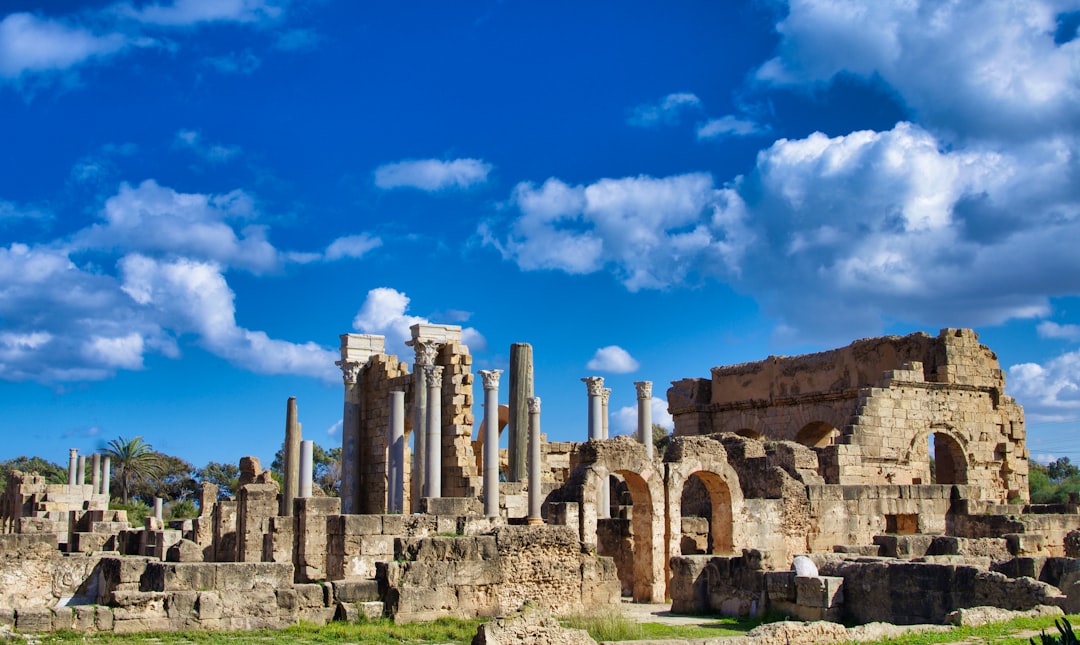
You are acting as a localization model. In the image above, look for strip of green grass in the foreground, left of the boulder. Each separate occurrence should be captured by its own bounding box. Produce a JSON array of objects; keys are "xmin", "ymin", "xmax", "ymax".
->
[{"xmin": 36, "ymin": 618, "xmax": 483, "ymax": 645}]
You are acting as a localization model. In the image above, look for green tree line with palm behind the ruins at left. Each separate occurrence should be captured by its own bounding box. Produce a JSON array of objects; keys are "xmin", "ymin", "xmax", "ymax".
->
[{"xmin": 0, "ymin": 436, "xmax": 341, "ymax": 523}]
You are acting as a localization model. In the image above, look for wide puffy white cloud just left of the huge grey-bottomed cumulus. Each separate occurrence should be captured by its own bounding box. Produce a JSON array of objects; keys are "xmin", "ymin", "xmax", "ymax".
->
[{"xmin": 481, "ymin": 173, "xmax": 752, "ymax": 291}]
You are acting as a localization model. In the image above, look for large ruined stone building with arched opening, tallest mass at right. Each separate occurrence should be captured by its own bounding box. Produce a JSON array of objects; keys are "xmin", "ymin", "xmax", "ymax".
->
[{"xmin": 667, "ymin": 330, "xmax": 1028, "ymax": 501}]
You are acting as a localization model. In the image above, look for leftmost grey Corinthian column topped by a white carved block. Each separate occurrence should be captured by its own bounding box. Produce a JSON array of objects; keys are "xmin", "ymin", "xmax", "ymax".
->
[{"xmin": 335, "ymin": 334, "xmax": 386, "ymax": 513}]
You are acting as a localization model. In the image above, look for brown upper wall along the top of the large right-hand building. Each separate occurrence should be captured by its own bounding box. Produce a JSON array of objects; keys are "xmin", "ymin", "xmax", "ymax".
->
[{"xmin": 708, "ymin": 328, "xmax": 1004, "ymax": 405}]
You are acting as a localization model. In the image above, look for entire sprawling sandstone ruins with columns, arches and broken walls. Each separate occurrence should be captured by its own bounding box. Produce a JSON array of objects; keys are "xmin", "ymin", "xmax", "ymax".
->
[{"xmin": 0, "ymin": 324, "xmax": 1080, "ymax": 637}]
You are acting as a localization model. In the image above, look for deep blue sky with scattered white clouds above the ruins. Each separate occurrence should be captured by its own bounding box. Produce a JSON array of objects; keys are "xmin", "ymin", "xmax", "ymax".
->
[{"xmin": 0, "ymin": 0, "xmax": 1080, "ymax": 473}]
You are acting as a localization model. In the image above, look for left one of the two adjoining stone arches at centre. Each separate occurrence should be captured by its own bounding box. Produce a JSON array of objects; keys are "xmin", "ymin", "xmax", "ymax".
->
[{"xmin": 571, "ymin": 436, "xmax": 667, "ymax": 603}]
